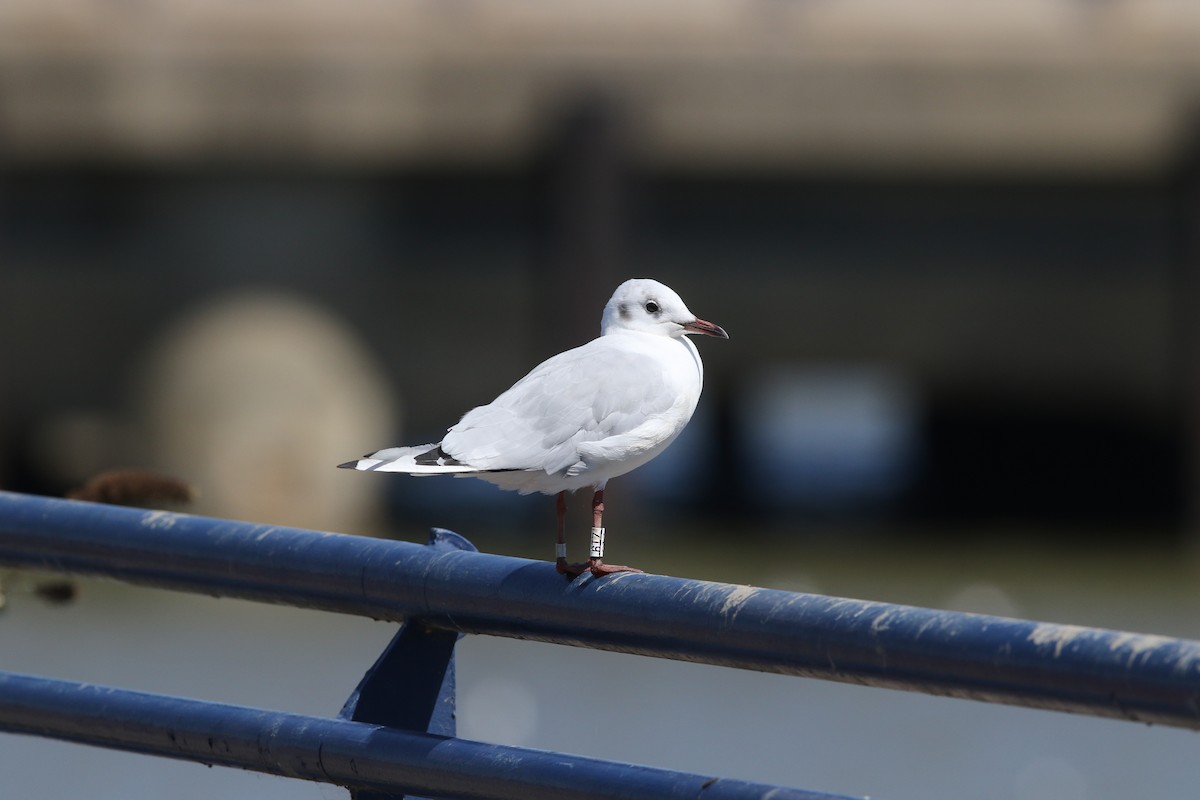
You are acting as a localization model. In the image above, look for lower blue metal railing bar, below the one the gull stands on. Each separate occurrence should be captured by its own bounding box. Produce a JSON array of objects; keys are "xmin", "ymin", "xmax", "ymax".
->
[{"xmin": 0, "ymin": 673, "xmax": 845, "ymax": 800}]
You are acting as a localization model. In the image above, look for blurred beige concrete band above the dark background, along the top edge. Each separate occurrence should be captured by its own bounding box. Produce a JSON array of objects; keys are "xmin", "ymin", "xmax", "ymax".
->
[{"xmin": 0, "ymin": 0, "xmax": 1200, "ymax": 170}]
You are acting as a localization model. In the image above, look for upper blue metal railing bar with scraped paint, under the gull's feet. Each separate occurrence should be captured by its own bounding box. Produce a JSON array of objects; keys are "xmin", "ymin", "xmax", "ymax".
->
[{"xmin": 0, "ymin": 492, "xmax": 1200, "ymax": 728}]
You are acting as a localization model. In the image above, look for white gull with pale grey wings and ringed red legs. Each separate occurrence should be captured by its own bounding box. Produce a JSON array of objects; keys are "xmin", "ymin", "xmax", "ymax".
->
[{"xmin": 338, "ymin": 278, "xmax": 728, "ymax": 576}]
